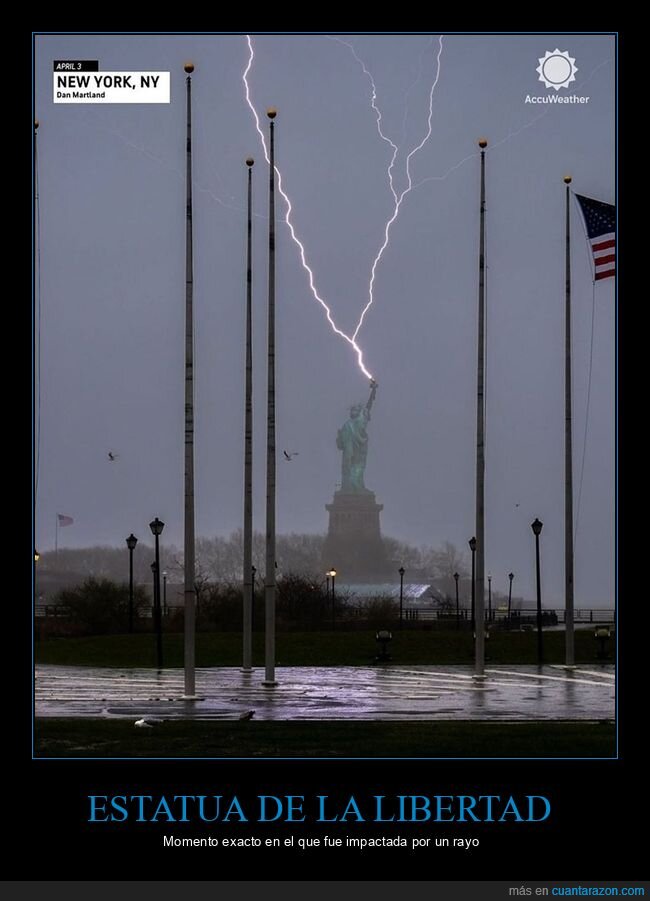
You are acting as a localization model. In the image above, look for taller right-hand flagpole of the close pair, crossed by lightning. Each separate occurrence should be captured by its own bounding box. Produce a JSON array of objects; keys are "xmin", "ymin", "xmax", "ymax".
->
[{"xmin": 263, "ymin": 109, "xmax": 277, "ymax": 687}]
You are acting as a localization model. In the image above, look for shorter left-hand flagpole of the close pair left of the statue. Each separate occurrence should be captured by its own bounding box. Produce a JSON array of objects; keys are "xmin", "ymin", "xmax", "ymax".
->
[{"xmin": 242, "ymin": 157, "xmax": 255, "ymax": 670}]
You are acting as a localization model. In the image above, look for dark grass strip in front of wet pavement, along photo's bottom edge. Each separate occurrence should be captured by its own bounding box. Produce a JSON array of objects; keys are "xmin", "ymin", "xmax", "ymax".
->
[{"xmin": 35, "ymin": 717, "xmax": 615, "ymax": 758}]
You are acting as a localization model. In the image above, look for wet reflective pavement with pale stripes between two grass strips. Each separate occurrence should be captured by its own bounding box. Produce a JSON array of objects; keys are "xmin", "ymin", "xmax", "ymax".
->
[{"xmin": 35, "ymin": 664, "xmax": 615, "ymax": 721}]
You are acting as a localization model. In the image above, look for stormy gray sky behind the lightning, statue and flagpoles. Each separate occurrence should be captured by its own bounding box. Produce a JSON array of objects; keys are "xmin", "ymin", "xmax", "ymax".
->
[{"xmin": 36, "ymin": 34, "xmax": 615, "ymax": 606}]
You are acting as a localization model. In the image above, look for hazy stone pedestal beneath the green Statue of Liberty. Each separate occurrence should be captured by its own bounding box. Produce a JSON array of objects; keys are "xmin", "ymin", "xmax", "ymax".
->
[{"xmin": 323, "ymin": 491, "xmax": 390, "ymax": 583}]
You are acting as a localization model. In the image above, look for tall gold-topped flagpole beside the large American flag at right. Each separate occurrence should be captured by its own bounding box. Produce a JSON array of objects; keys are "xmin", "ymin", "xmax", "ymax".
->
[{"xmin": 564, "ymin": 175, "xmax": 575, "ymax": 666}]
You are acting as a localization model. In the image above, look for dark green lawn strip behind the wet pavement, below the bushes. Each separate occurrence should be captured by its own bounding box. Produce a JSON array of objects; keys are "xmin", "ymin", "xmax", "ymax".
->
[{"xmin": 35, "ymin": 629, "xmax": 614, "ymax": 667}]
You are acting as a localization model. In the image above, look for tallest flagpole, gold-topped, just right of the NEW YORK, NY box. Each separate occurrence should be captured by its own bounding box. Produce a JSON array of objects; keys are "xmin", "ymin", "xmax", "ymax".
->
[{"xmin": 183, "ymin": 62, "xmax": 196, "ymax": 699}]
